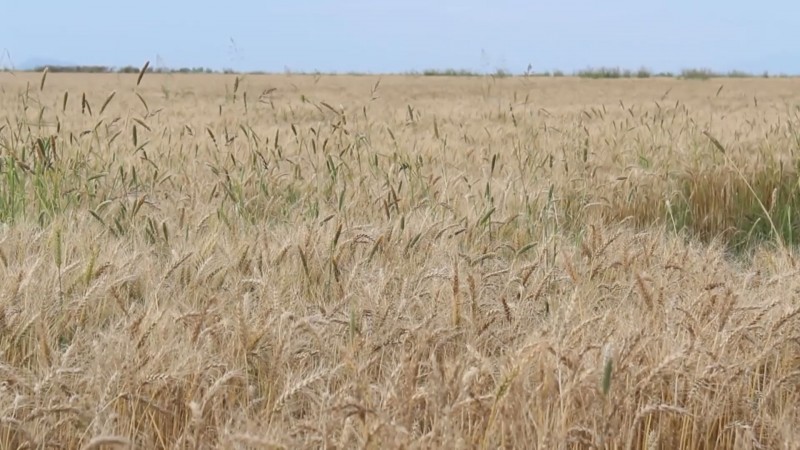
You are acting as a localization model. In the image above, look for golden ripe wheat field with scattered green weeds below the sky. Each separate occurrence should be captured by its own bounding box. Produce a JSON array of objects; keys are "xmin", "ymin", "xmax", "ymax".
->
[{"xmin": 0, "ymin": 73, "xmax": 800, "ymax": 449}]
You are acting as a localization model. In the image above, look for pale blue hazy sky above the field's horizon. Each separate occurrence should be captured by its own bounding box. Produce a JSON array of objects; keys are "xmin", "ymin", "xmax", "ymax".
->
[{"xmin": 0, "ymin": 0, "xmax": 800, "ymax": 74}]
